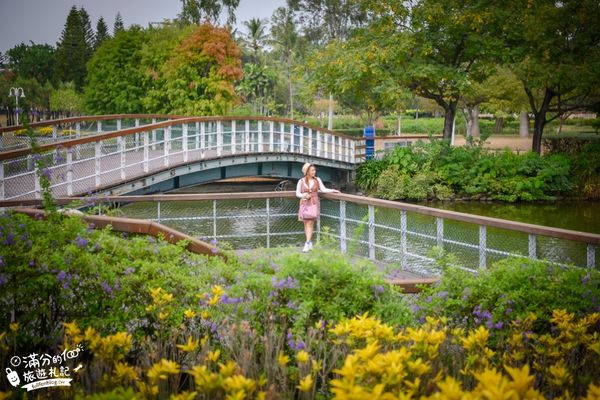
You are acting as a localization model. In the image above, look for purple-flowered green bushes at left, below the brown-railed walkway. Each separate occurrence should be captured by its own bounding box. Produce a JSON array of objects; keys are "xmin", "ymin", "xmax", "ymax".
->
[{"xmin": 0, "ymin": 214, "xmax": 411, "ymax": 348}]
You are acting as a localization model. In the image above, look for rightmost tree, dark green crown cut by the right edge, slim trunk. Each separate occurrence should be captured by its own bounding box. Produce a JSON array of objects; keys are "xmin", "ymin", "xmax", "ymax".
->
[{"xmin": 509, "ymin": 0, "xmax": 600, "ymax": 153}]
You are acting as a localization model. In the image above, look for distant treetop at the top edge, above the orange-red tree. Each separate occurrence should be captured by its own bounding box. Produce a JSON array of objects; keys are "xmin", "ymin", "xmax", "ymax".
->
[{"xmin": 178, "ymin": 0, "xmax": 240, "ymax": 25}]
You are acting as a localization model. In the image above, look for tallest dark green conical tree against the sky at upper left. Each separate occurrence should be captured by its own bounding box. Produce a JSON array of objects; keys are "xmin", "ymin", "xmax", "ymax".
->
[{"xmin": 54, "ymin": 6, "xmax": 90, "ymax": 90}]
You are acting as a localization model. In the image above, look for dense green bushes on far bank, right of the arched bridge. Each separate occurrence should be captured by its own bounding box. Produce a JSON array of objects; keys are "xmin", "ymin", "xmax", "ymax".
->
[{"xmin": 357, "ymin": 140, "xmax": 584, "ymax": 202}]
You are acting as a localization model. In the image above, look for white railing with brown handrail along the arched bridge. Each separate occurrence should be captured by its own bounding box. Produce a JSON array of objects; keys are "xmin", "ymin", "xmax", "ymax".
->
[{"xmin": 0, "ymin": 116, "xmax": 363, "ymax": 200}]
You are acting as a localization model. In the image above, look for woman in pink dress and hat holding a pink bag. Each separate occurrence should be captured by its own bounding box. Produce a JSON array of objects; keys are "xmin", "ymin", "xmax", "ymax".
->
[{"xmin": 296, "ymin": 163, "xmax": 340, "ymax": 252}]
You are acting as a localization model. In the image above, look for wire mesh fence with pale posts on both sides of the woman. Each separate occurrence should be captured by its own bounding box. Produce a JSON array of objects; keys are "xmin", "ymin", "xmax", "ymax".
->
[{"xmin": 72, "ymin": 194, "xmax": 598, "ymax": 273}]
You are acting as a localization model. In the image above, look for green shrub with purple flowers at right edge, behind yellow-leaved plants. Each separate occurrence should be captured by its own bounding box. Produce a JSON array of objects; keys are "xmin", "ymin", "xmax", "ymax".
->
[{"xmin": 417, "ymin": 258, "xmax": 600, "ymax": 329}]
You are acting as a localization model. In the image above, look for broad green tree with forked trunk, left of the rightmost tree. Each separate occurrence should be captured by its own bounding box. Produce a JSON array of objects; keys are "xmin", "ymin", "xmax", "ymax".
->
[{"xmin": 365, "ymin": 0, "xmax": 504, "ymax": 139}]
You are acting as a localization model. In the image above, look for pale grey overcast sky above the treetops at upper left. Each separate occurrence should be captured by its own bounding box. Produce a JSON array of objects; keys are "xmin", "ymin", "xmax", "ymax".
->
[{"xmin": 0, "ymin": 0, "xmax": 285, "ymax": 53}]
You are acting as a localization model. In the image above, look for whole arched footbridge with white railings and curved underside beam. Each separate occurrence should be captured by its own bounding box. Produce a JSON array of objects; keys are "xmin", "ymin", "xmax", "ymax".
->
[{"xmin": 0, "ymin": 114, "xmax": 364, "ymax": 200}]
